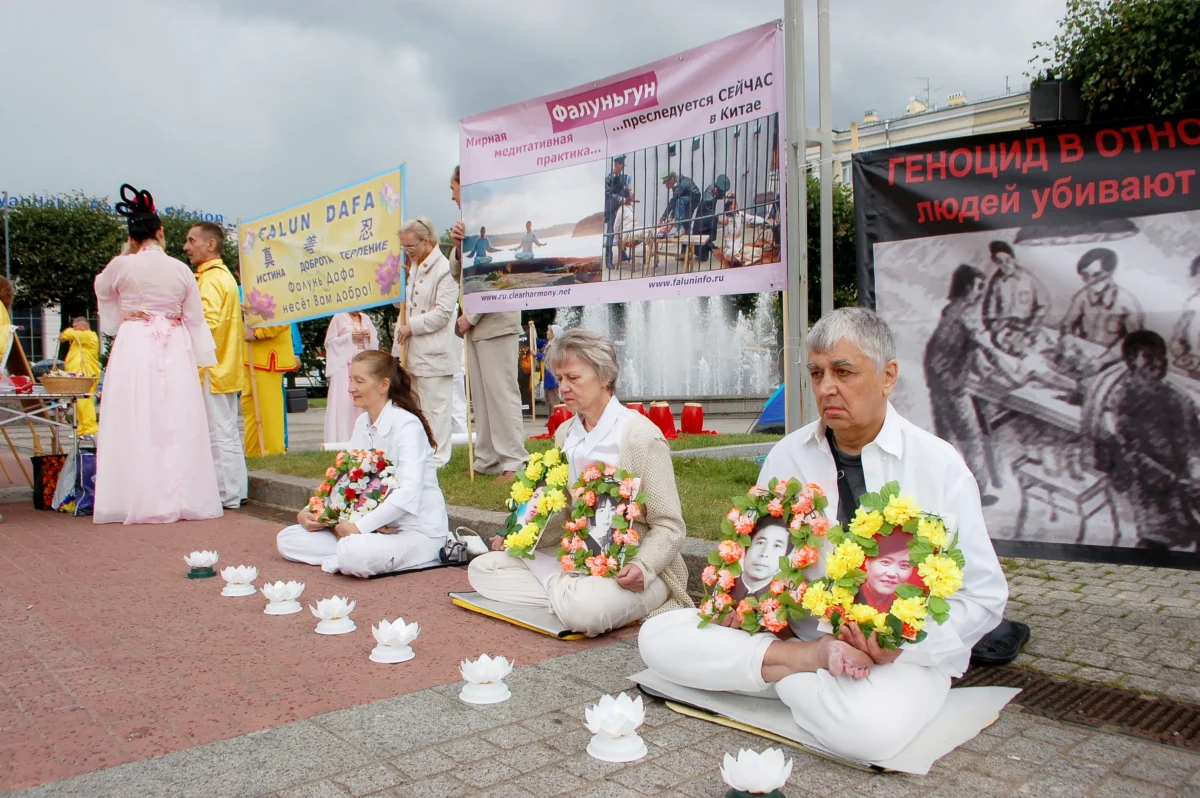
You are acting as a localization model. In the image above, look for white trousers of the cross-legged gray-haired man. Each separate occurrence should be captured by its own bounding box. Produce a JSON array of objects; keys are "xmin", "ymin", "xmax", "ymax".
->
[{"xmin": 637, "ymin": 610, "xmax": 950, "ymax": 762}]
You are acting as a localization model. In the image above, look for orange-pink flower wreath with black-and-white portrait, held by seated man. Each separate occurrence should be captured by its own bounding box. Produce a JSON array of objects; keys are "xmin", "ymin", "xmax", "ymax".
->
[{"xmin": 700, "ymin": 479, "xmax": 839, "ymax": 634}]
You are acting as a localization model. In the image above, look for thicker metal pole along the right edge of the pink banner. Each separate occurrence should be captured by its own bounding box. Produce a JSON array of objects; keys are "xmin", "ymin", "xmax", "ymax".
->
[{"xmin": 784, "ymin": 0, "xmax": 812, "ymax": 432}]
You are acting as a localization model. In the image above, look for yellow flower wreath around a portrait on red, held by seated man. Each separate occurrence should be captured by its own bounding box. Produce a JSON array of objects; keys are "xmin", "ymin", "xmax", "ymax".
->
[{"xmin": 802, "ymin": 482, "xmax": 966, "ymax": 649}]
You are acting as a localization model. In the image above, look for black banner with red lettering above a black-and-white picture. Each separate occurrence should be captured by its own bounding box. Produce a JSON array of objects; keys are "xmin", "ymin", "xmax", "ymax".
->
[{"xmin": 854, "ymin": 114, "xmax": 1200, "ymax": 569}]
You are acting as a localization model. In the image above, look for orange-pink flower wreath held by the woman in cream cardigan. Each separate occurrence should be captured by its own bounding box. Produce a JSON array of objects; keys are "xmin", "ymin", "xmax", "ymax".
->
[{"xmin": 558, "ymin": 463, "xmax": 646, "ymax": 578}]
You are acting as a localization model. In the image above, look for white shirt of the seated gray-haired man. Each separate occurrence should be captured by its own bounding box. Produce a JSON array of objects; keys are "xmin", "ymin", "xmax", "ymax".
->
[{"xmin": 758, "ymin": 402, "xmax": 1008, "ymax": 677}]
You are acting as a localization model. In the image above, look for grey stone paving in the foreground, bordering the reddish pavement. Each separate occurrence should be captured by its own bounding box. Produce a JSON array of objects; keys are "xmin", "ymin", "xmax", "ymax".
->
[{"xmin": 17, "ymin": 640, "xmax": 1200, "ymax": 798}]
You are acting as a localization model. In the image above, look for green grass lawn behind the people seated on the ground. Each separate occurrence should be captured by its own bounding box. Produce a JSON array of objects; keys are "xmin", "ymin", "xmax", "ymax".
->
[{"xmin": 250, "ymin": 436, "xmax": 772, "ymax": 540}]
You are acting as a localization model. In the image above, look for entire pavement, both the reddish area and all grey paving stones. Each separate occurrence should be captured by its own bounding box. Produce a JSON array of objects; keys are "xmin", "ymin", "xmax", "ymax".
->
[{"xmin": 0, "ymin": 504, "xmax": 1200, "ymax": 798}]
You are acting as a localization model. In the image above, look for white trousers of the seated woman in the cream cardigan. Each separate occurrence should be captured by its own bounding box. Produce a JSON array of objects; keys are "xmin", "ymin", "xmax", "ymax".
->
[{"xmin": 467, "ymin": 552, "xmax": 670, "ymax": 637}]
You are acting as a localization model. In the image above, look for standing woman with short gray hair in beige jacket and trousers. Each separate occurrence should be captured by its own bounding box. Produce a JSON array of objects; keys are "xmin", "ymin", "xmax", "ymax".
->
[{"xmin": 391, "ymin": 217, "xmax": 462, "ymax": 468}]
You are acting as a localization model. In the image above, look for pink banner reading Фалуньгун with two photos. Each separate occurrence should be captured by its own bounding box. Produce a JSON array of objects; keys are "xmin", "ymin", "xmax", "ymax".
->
[{"xmin": 458, "ymin": 23, "xmax": 786, "ymax": 313}]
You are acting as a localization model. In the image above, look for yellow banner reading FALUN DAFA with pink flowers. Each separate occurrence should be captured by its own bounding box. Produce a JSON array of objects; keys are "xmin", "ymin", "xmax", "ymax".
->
[{"xmin": 238, "ymin": 166, "xmax": 406, "ymax": 326}]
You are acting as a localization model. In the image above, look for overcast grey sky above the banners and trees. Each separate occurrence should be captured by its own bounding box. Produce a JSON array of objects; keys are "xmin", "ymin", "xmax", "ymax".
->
[{"xmin": 0, "ymin": 0, "xmax": 1064, "ymax": 234}]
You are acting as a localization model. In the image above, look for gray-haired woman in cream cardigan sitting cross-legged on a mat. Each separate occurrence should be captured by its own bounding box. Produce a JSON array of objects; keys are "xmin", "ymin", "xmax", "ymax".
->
[{"xmin": 468, "ymin": 329, "xmax": 694, "ymax": 637}]
